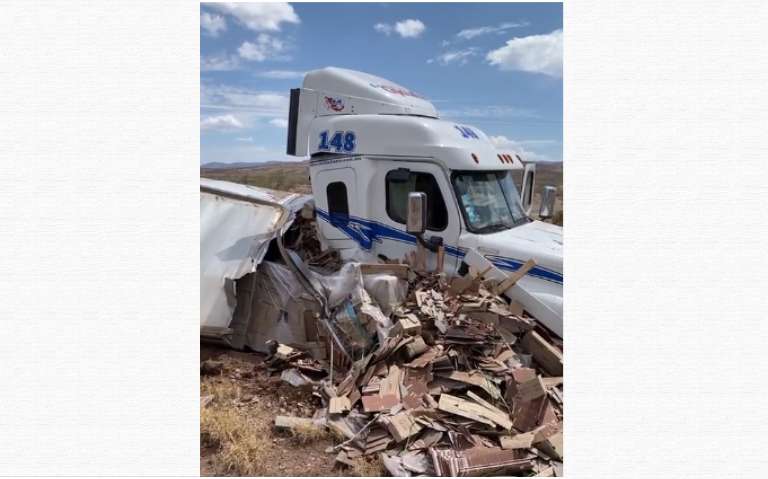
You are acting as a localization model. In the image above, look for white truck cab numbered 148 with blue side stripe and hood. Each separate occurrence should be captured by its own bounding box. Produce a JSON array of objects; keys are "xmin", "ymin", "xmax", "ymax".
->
[{"xmin": 287, "ymin": 67, "xmax": 563, "ymax": 336}]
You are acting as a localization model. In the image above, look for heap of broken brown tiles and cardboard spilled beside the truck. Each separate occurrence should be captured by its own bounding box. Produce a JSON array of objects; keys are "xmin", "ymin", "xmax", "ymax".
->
[{"xmin": 268, "ymin": 265, "xmax": 563, "ymax": 476}]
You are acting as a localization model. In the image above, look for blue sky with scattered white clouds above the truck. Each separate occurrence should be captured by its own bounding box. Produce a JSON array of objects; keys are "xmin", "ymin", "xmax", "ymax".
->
[{"xmin": 200, "ymin": 3, "xmax": 563, "ymax": 163}]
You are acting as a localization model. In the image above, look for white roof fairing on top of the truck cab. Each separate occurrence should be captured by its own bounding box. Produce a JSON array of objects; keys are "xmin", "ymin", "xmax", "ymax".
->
[{"xmin": 286, "ymin": 67, "xmax": 523, "ymax": 170}]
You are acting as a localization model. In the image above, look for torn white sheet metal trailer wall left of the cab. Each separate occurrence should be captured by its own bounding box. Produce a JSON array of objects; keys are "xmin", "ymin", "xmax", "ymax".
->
[{"xmin": 200, "ymin": 178, "xmax": 311, "ymax": 336}]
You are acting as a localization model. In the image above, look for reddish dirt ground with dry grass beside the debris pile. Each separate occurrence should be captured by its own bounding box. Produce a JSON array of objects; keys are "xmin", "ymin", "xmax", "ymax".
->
[{"xmin": 200, "ymin": 344, "xmax": 384, "ymax": 476}]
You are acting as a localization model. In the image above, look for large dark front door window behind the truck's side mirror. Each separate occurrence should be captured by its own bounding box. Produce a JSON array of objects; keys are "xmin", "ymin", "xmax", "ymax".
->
[{"xmin": 385, "ymin": 170, "xmax": 448, "ymax": 231}]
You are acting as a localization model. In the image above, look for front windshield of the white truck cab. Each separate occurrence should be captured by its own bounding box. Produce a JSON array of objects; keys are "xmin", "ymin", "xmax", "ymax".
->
[{"xmin": 453, "ymin": 170, "xmax": 528, "ymax": 233}]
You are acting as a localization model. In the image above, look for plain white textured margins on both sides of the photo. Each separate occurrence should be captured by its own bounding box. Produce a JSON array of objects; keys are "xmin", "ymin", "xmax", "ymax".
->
[{"xmin": 0, "ymin": 0, "xmax": 768, "ymax": 478}]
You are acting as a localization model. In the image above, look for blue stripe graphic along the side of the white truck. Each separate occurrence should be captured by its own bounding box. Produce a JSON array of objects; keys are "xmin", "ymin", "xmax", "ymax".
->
[{"xmin": 316, "ymin": 208, "xmax": 563, "ymax": 284}]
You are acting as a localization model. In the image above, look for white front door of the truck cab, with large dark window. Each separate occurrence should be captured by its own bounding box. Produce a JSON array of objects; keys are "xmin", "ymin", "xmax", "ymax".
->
[{"xmin": 370, "ymin": 160, "xmax": 461, "ymax": 273}]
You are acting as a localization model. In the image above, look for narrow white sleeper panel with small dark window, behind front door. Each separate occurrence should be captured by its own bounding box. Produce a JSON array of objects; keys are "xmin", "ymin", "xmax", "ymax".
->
[{"xmin": 315, "ymin": 168, "xmax": 360, "ymax": 249}]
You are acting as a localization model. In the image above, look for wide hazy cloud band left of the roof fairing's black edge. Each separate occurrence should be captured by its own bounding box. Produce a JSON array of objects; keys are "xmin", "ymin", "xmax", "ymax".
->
[{"xmin": 200, "ymin": 83, "xmax": 289, "ymax": 118}]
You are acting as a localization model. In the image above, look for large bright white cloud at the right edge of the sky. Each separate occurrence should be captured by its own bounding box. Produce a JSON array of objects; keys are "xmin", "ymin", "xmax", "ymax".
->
[{"xmin": 486, "ymin": 30, "xmax": 563, "ymax": 77}]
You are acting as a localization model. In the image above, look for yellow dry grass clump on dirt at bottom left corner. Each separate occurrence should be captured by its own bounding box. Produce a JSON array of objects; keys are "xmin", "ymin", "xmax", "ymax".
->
[{"xmin": 200, "ymin": 379, "xmax": 269, "ymax": 476}]
